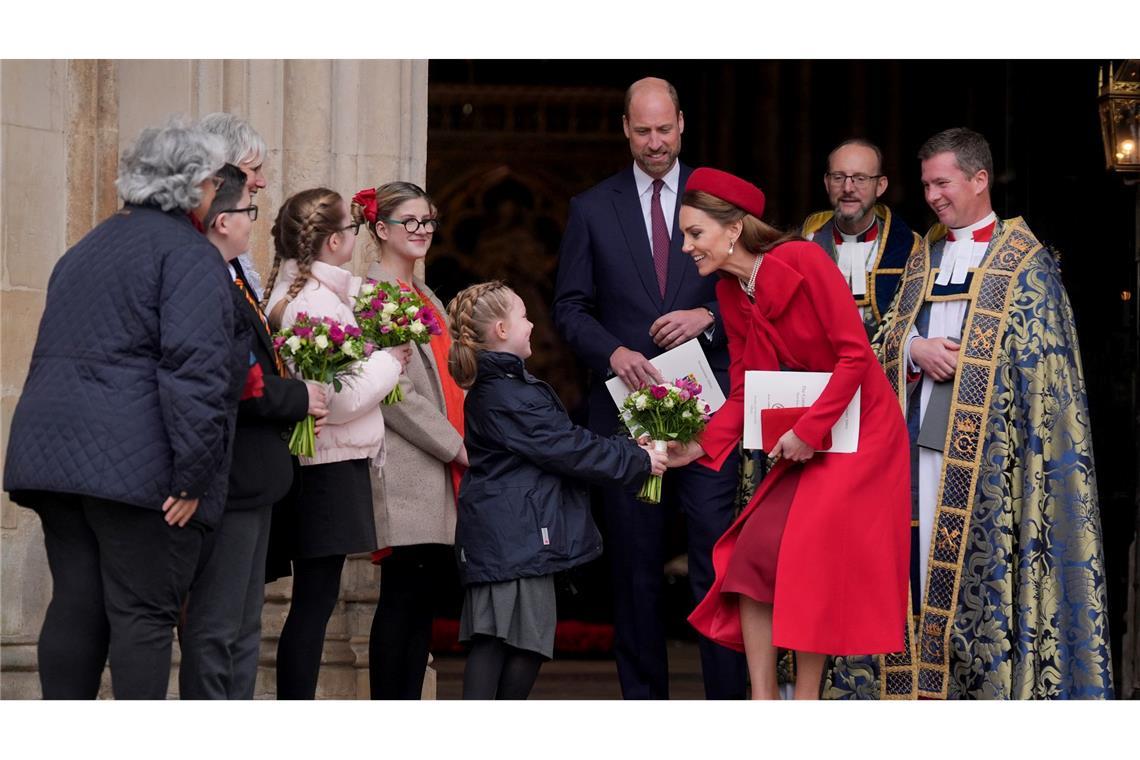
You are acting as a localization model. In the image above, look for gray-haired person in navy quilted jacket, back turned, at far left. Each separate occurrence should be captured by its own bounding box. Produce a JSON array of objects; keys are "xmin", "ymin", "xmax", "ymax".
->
[{"xmin": 3, "ymin": 123, "xmax": 249, "ymax": 698}]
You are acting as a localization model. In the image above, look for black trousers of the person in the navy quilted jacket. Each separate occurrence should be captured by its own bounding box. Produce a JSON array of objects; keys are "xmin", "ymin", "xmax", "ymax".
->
[{"xmin": 34, "ymin": 493, "xmax": 204, "ymax": 700}]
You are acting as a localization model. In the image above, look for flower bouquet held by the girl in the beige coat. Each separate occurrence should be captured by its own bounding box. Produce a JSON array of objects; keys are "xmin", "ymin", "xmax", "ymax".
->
[{"xmin": 352, "ymin": 278, "xmax": 443, "ymax": 404}]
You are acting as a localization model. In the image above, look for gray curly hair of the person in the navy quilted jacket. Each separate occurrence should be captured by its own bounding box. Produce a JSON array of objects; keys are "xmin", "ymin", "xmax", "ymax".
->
[{"xmin": 115, "ymin": 120, "xmax": 226, "ymax": 211}]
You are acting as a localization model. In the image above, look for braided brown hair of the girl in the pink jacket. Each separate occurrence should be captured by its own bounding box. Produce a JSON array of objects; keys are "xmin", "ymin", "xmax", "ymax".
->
[{"xmin": 261, "ymin": 187, "xmax": 344, "ymax": 329}]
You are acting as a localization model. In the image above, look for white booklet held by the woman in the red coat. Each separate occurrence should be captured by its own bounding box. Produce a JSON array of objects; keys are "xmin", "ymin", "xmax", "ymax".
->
[{"xmin": 744, "ymin": 370, "xmax": 862, "ymax": 453}]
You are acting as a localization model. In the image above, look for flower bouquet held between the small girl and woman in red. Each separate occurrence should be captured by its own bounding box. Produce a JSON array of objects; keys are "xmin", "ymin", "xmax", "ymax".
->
[{"xmin": 621, "ymin": 376, "xmax": 709, "ymax": 504}]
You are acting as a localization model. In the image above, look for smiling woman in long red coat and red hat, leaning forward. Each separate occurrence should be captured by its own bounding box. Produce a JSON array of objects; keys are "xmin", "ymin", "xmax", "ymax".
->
[{"xmin": 669, "ymin": 169, "xmax": 911, "ymax": 698}]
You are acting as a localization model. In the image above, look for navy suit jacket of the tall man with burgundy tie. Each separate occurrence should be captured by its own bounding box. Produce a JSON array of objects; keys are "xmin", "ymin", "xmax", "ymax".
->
[{"xmin": 553, "ymin": 164, "xmax": 728, "ymax": 434}]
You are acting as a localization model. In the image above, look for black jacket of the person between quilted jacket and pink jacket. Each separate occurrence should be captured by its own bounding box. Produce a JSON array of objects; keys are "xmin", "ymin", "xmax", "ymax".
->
[{"xmin": 226, "ymin": 261, "xmax": 309, "ymax": 509}]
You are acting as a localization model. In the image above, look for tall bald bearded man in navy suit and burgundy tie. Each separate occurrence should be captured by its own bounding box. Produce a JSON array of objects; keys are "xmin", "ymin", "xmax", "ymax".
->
[{"xmin": 553, "ymin": 79, "xmax": 747, "ymax": 698}]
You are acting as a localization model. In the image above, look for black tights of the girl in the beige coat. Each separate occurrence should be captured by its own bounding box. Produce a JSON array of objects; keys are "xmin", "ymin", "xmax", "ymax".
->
[{"xmin": 368, "ymin": 545, "xmax": 455, "ymax": 700}]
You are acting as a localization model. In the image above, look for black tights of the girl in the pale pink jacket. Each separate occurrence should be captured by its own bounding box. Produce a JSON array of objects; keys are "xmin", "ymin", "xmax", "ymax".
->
[{"xmin": 277, "ymin": 555, "xmax": 344, "ymax": 700}]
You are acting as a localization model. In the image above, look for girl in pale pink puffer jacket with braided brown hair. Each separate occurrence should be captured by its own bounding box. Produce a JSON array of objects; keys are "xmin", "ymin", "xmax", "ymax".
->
[{"xmin": 266, "ymin": 188, "xmax": 410, "ymax": 700}]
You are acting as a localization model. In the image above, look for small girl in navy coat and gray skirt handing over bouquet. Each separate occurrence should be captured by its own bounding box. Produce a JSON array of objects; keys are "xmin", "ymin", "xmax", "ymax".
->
[{"xmin": 448, "ymin": 281, "xmax": 666, "ymax": 700}]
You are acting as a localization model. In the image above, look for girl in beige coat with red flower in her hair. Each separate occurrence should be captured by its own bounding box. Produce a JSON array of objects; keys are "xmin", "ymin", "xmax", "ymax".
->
[{"xmin": 352, "ymin": 182, "xmax": 467, "ymax": 700}]
